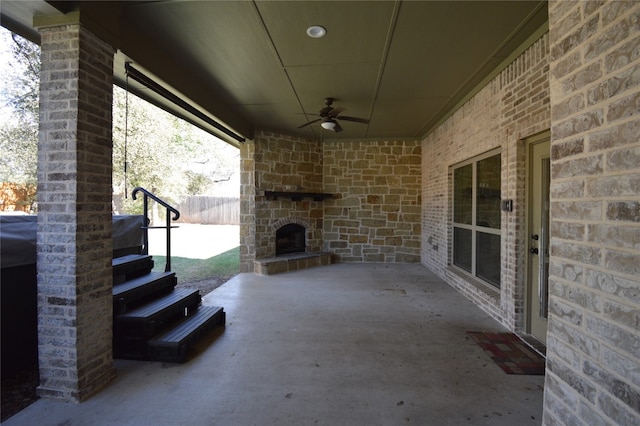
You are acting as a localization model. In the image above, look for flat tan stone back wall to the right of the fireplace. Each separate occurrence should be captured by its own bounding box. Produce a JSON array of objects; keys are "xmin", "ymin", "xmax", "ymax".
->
[{"xmin": 323, "ymin": 141, "xmax": 421, "ymax": 262}]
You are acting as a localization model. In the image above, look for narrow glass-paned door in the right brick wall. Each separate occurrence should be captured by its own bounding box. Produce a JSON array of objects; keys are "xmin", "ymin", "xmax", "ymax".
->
[{"xmin": 527, "ymin": 137, "xmax": 550, "ymax": 345}]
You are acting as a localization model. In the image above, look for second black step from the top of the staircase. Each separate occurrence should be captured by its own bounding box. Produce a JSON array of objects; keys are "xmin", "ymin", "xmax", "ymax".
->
[{"xmin": 112, "ymin": 272, "xmax": 176, "ymax": 317}]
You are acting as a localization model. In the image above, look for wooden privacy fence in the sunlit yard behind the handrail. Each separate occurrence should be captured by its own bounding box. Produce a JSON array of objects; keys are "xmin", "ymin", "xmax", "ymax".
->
[{"xmin": 178, "ymin": 195, "xmax": 240, "ymax": 225}]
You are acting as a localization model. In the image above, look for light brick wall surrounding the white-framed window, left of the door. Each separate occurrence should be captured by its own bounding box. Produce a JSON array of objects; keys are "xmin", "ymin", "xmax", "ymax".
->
[{"xmin": 421, "ymin": 35, "xmax": 550, "ymax": 331}]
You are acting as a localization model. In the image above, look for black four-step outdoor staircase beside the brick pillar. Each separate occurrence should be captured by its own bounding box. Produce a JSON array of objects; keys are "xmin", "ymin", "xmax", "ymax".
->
[{"xmin": 112, "ymin": 188, "xmax": 225, "ymax": 363}]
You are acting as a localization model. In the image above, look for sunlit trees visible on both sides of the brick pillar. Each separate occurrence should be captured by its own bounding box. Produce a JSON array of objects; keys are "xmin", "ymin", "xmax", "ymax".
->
[{"xmin": 0, "ymin": 30, "xmax": 239, "ymax": 211}]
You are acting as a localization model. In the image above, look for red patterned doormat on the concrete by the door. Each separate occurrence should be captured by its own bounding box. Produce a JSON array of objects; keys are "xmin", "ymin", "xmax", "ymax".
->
[{"xmin": 467, "ymin": 331, "xmax": 545, "ymax": 376}]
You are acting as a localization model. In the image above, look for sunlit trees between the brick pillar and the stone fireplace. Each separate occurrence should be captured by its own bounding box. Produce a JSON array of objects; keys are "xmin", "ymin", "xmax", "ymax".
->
[{"xmin": 113, "ymin": 87, "xmax": 239, "ymax": 213}]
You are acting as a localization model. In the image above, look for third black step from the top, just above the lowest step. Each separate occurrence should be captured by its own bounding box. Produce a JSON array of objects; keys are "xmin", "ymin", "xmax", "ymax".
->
[{"xmin": 113, "ymin": 288, "xmax": 202, "ymax": 359}]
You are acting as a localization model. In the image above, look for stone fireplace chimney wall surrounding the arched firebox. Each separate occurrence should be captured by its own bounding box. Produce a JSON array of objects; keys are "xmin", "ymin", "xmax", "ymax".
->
[{"xmin": 240, "ymin": 132, "xmax": 323, "ymax": 272}]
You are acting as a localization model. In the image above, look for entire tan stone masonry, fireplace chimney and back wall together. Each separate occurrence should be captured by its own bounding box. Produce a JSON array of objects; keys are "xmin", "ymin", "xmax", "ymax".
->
[{"xmin": 240, "ymin": 132, "xmax": 421, "ymax": 272}]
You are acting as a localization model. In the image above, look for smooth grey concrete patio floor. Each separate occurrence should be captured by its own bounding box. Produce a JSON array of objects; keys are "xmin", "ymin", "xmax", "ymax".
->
[{"xmin": 3, "ymin": 264, "xmax": 544, "ymax": 426}]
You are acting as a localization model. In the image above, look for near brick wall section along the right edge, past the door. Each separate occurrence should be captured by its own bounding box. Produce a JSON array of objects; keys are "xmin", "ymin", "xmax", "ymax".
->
[{"xmin": 544, "ymin": 1, "xmax": 640, "ymax": 425}]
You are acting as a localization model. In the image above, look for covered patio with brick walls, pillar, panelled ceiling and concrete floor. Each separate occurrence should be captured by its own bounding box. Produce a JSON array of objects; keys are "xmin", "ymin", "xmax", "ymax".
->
[{"xmin": 1, "ymin": 0, "xmax": 640, "ymax": 426}]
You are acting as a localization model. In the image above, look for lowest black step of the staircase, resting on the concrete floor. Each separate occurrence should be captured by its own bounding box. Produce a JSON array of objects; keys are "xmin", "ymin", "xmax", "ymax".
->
[{"xmin": 149, "ymin": 306, "xmax": 225, "ymax": 363}]
